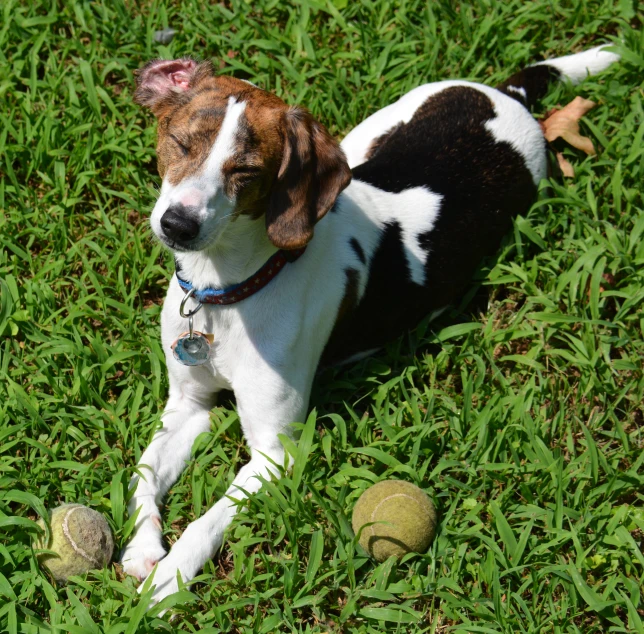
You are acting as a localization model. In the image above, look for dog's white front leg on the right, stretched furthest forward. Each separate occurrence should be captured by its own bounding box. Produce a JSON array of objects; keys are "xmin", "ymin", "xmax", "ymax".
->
[{"xmin": 143, "ymin": 366, "xmax": 312, "ymax": 603}]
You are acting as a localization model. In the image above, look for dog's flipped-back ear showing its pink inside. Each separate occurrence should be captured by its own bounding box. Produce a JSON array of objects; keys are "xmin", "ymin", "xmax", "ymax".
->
[{"xmin": 134, "ymin": 57, "xmax": 212, "ymax": 115}]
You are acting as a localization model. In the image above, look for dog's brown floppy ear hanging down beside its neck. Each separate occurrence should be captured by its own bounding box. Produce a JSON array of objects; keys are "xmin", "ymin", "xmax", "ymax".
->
[{"xmin": 266, "ymin": 108, "xmax": 351, "ymax": 249}]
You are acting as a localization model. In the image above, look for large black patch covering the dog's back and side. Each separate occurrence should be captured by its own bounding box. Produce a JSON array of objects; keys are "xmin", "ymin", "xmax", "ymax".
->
[{"xmin": 322, "ymin": 86, "xmax": 536, "ymax": 365}]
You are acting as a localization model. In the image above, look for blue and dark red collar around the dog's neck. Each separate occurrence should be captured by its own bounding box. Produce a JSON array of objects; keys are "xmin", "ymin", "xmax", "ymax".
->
[{"xmin": 174, "ymin": 247, "xmax": 306, "ymax": 304}]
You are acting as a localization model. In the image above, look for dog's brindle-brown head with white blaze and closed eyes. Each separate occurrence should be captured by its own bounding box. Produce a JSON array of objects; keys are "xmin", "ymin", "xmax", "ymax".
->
[{"xmin": 135, "ymin": 59, "xmax": 351, "ymax": 251}]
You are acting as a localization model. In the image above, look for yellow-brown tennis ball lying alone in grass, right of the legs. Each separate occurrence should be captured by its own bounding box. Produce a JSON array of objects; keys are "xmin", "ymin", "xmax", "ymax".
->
[{"xmin": 352, "ymin": 480, "xmax": 436, "ymax": 561}]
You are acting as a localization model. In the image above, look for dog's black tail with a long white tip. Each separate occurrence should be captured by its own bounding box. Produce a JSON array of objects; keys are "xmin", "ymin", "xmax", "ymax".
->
[{"xmin": 497, "ymin": 45, "xmax": 619, "ymax": 108}]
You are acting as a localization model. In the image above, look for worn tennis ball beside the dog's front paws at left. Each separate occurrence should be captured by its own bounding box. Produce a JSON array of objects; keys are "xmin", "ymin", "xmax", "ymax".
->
[{"xmin": 35, "ymin": 504, "xmax": 114, "ymax": 581}]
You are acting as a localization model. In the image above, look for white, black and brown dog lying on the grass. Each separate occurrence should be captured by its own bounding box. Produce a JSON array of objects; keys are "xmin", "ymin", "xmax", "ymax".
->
[{"xmin": 121, "ymin": 47, "xmax": 619, "ymax": 603}]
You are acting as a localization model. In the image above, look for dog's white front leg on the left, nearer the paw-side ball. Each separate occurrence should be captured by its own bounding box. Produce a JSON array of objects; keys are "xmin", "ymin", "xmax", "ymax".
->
[{"xmin": 121, "ymin": 390, "xmax": 214, "ymax": 579}]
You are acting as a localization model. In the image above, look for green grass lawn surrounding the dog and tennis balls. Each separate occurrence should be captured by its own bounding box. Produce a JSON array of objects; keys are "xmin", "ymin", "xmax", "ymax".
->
[{"xmin": 0, "ymin": 0, "xmax": 644, "ymax": 634}]
